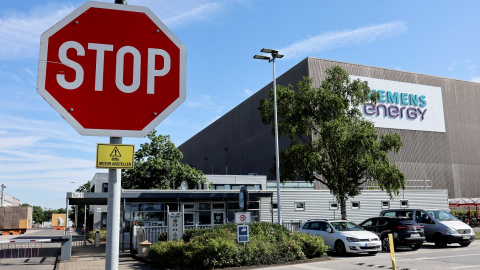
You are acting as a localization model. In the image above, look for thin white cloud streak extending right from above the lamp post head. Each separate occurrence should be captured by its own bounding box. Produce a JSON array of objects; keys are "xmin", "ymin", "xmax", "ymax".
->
[{"xmin": 280, "ymin": 22, "xmax": 407, "ymax": 59}]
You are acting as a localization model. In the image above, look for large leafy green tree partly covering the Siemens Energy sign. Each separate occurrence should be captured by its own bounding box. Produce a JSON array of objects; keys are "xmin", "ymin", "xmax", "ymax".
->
[{"xmin": 259, "ymin": 66, "xmax": 405, "ymax": 219}]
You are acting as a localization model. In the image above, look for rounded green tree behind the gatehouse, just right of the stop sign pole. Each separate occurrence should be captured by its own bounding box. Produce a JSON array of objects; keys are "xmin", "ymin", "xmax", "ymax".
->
[{"xmin": 122, "ymin": 130, "xmax": 207, "ymax": 189}]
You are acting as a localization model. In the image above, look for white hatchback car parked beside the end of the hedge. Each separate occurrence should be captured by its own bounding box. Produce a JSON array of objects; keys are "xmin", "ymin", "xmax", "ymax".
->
[{"xmin": 299, "ymin": 219, "xmax": 382, "ymax": 255}]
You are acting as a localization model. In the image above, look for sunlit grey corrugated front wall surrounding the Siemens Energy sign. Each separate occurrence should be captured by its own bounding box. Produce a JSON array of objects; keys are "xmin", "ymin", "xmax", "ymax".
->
[{"xmin": 308, "ymin": 58, "xmax": 480, "ymax": 198}]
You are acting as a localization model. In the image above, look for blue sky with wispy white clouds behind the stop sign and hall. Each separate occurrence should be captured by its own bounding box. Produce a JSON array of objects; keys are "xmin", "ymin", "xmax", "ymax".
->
[{"xmin": 0, "ymin": 0, "xmax": 480, "ymax": 209}]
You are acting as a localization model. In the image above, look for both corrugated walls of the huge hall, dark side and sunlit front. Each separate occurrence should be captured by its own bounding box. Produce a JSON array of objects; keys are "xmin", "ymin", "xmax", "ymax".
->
[{"xmin": 179, "ymin": 58, "xmax": 480, "ymax": 198}]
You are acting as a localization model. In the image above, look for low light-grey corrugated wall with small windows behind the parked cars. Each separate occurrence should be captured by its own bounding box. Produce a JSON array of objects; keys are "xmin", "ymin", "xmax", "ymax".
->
[{"xmin": 261, "ymin": 189, "xmax": 448, "ymax": 223}]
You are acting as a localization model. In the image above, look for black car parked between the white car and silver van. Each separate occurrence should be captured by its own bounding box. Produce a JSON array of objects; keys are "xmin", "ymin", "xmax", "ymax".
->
[{"xmin": 360, "ymin": 217, "xmax": 425, "ymax": 251}]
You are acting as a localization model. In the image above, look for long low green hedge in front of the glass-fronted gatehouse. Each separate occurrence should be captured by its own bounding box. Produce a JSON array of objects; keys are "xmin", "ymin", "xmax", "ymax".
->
[{"xmin": 149, "ymin": 222, "xmax": 326, "ymax": 269}]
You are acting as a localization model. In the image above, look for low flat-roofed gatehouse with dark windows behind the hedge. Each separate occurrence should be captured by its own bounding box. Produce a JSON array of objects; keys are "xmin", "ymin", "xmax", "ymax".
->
[{"xmin": 67, "ymin": 189, "xmax": 273, "ymax": 250}]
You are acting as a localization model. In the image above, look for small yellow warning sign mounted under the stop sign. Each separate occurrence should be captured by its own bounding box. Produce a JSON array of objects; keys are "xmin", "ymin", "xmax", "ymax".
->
[{"xmin": 97, "ymin": 143, "xmax": 135, "ymax": 169}]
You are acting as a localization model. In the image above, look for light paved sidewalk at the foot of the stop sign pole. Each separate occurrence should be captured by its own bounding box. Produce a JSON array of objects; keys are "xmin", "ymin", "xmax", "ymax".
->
[{"xmin": 56, "ymin": 243, "xmax": 156, "ymax": 270}]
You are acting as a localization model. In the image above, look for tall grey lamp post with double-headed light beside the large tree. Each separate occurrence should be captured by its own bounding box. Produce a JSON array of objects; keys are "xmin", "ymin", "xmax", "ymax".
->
[{"xmin": 253, "ymin": 48, "xmax": 283, "ymax": 224}]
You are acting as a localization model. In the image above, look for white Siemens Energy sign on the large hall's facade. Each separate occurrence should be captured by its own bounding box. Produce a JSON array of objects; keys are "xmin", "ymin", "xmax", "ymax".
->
[{"xmin": 350, "ymin": 76, "xmax": 445, "ymax": 132}]
